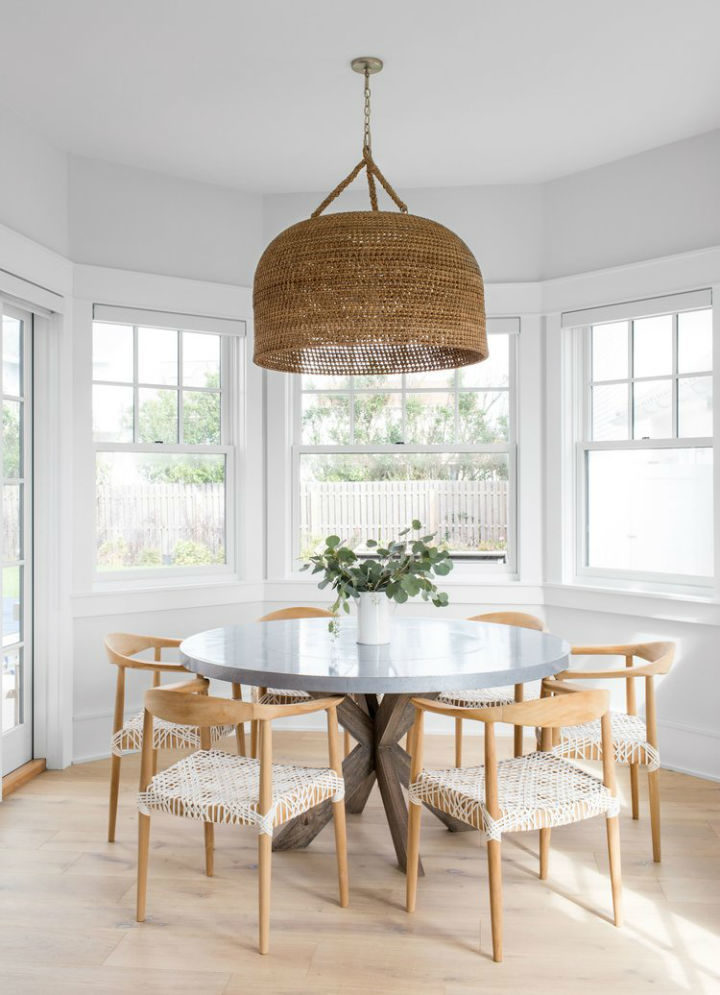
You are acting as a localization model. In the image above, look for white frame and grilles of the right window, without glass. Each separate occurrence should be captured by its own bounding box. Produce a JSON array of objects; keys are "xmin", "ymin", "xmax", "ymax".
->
[{"xmin": 562, "ymin": 290, "xmax": 718, "ymax": 596}]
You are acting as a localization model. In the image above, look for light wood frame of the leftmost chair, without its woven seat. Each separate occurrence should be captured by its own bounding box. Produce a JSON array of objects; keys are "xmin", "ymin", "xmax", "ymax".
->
[{"xmin": 105, "ymin": 632, "xmax": 245, "ymax": 843}]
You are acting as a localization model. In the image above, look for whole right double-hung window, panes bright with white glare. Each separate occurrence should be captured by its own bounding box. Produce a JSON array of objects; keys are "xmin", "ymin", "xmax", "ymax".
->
[{"xmin": 564, "ymin": 291, "xmax": 713, "ymax": 587}]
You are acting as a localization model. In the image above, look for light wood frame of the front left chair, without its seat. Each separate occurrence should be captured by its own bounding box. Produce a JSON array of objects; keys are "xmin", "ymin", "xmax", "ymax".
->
[{"xmin": 137, "ymin": 677, "xmax": 349, "ymax": 954}]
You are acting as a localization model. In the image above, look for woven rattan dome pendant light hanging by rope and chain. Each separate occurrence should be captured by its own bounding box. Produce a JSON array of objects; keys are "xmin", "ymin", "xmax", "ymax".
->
[{"xmin": 253, "ymin": 58, "xmax": 488, "ymax": 375}]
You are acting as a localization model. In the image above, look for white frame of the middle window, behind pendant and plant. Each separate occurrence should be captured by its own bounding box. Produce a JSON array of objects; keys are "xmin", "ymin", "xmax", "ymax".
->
[{"xmin": 289, "ymin": 317, "xmax": 521, "ymax": 580}]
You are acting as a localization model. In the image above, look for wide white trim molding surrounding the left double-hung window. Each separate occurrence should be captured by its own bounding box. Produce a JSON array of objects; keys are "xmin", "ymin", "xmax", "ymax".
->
[{"xmin": 73, "ymin": 265, "xmax": 265, "ymax": 610}]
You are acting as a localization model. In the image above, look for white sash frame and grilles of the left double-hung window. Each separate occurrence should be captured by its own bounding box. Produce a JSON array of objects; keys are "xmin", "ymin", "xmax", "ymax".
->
[{"xmin": 91, "ymin": 316, "xmax": 245, "ymax": 588}]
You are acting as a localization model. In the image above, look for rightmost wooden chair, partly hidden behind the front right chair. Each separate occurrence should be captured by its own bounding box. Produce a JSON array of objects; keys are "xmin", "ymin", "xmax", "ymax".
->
[{"xmin": 544, "ymin": 642, "xmax": 675, "ymax": 863}]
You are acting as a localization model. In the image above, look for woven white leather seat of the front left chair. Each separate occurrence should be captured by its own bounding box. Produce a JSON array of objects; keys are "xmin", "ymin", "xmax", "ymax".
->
[{"xmin": 138, "ymin": 750, "xmax": 345, "ymax": 836}]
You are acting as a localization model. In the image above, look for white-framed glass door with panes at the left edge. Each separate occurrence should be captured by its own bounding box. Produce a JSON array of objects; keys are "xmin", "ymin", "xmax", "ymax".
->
[{"xmin": 0, "ymin": 305, "xmax": 33, "ymax": 774}]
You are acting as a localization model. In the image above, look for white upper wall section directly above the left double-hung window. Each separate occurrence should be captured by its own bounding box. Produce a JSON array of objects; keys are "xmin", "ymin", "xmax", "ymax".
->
[{"xmin": 69, "ymin": 156, "xmax": 262, "ymax": 287}]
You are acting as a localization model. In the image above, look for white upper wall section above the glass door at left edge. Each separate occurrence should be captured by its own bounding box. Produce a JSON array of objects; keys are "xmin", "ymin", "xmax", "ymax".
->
[{"xmin": 0, "ymin": 110, "xmax": 69, "ymax": 255}]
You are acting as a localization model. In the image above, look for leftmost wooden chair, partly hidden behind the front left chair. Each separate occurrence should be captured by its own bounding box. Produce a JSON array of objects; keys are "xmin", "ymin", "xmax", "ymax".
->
[{"xmin": 105, "ymin": 632, "xmax": 245, "ymax": 843}]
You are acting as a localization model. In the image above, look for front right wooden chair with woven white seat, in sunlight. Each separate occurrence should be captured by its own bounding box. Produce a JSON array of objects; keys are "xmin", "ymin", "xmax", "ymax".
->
[{"xmin": 407, "ymin": 681, "xmax": 622, "ymax": 961}]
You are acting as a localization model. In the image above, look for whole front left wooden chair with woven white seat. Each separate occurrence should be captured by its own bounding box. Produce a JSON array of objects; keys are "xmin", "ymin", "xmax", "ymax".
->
[{"xmin": 137, "ymin": 678, "xmax": 348, "ymax": 954}]
